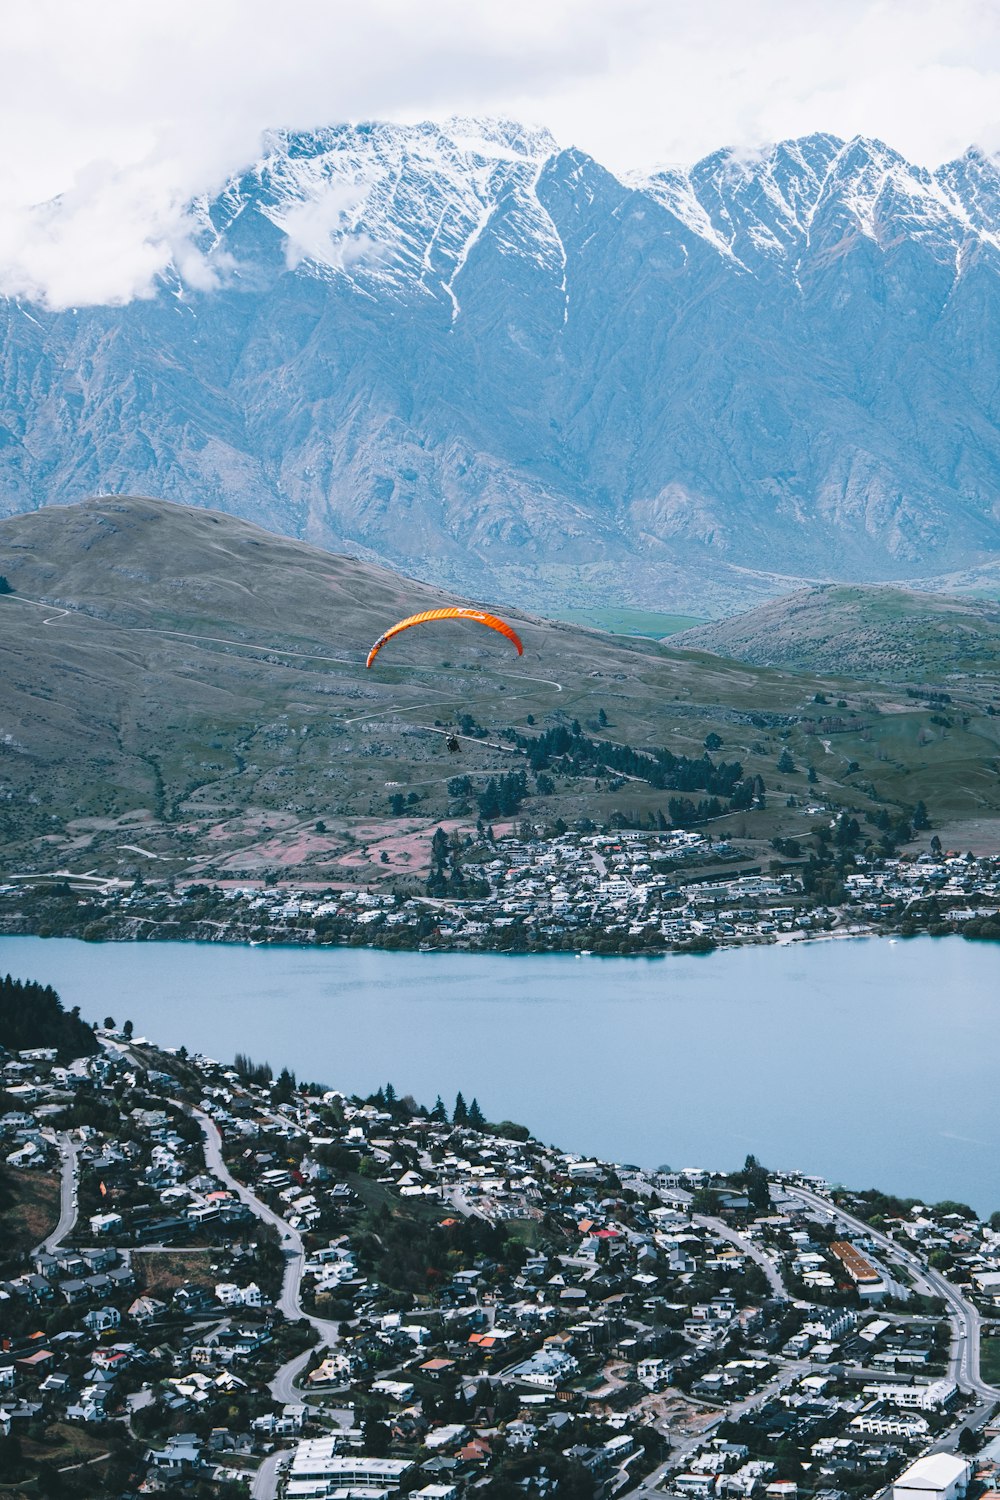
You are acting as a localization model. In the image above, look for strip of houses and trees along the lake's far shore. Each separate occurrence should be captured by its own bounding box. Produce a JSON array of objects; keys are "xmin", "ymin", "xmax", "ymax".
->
[{"xmin": 0, "ymin": 828, "xmax": 1000, "ymax": 954}]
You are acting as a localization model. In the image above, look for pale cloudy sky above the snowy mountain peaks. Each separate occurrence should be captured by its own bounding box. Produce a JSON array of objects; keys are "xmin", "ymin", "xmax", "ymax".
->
[{"xmin": 0, "ymin": 0, "xmax": 1000, "ymax": 306}]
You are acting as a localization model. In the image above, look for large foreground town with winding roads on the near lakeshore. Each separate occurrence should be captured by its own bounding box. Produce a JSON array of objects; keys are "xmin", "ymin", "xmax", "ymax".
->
[{"xmin": 0, "ymin": 996, "xmax": 1000, "ymax": 1500}]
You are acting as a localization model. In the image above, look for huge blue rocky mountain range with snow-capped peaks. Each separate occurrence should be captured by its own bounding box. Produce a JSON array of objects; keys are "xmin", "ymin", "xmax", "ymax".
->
[{"xmin": 0, "ymin": 120, "xmax": 1000, "ymax": 609}]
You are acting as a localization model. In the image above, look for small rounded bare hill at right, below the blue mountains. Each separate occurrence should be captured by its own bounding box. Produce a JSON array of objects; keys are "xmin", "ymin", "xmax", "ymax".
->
[{"xmin": 672, "ymin": 585, "xmax": 1000, "ymax": 683}]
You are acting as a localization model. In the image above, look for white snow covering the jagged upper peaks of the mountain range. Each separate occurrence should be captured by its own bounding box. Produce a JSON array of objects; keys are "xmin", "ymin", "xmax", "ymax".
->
[{"xmin": 200, "ymin": 116, "xmax": 1000, "ymax": 301}]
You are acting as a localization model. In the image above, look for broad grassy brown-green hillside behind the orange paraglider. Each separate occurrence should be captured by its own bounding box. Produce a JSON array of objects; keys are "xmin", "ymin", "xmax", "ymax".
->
[{"xmin": 0, "ymin": 500, "xmax": 1000, "ymax": 881}]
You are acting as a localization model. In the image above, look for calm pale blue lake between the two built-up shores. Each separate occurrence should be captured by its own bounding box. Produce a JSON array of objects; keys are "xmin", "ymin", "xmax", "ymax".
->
[{"xmin": 0, "ymin": 938, "xmax": 1000, "ymax": 1214}]
